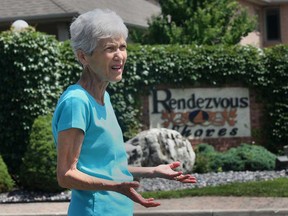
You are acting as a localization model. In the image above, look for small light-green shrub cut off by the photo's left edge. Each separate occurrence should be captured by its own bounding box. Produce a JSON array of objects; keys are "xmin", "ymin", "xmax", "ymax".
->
[{"xmin": 0, "ymin": 155, "xmax": 14, "ymax": 193}]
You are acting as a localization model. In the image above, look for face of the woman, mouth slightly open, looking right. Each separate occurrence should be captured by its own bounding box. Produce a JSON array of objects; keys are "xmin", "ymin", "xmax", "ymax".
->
[{"xmin": 86, "ymin": 37, "xmax": 127, "ymax": 82}]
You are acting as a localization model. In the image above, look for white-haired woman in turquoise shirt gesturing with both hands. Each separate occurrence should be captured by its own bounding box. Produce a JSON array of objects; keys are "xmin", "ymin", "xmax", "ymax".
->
[{"xmin": 52, "ymin": 9, "xmax": 196, "ymax": 216}]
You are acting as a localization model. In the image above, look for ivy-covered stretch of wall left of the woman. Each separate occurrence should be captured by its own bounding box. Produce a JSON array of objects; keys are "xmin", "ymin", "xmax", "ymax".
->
[{"xmin": 0, "ymin": 29, "xmax": 61, "ymax": 174}]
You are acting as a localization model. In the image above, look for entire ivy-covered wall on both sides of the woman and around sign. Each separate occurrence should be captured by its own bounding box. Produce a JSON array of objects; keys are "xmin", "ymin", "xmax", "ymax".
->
[{"xmin": 0, "ymin": 29, "xmax": 288, "ymax": 175}]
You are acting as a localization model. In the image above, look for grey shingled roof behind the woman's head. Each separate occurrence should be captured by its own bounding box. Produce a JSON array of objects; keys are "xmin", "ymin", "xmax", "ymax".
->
[{"xmin": 0, "ymin": 0, "xmax": 161, "ymax": 41}]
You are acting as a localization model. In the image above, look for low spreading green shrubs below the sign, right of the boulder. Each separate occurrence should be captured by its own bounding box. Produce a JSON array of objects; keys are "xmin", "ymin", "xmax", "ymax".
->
[{"xmin": 194, "ymin": 144, "xmax": 276, "ymax": 173}]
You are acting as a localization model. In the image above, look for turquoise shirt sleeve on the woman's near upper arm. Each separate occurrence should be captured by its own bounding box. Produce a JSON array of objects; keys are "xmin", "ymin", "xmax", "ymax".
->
[{"xmin": 57, "ymin": 97, "xmax": 89, "ymax": 133}]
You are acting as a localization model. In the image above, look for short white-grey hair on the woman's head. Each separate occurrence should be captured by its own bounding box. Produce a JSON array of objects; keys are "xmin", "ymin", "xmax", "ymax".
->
[{"xmin": 70, "ymin": 9, "xmax": 128, "ymax": 56}]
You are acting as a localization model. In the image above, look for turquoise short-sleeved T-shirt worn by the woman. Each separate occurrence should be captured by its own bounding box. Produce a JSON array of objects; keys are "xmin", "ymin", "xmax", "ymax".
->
[{"xmin": 52, "ymin": 84, "xmax": 134, "ymax": 216}]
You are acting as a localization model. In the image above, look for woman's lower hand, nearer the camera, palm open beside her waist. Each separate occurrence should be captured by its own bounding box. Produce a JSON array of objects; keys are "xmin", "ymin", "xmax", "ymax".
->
[{"xmin": 116, "ymin": 181, "xmax": 160, "ymax": 208}]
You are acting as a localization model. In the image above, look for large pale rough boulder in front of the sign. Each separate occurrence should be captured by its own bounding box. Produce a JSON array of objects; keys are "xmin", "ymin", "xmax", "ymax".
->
[{"xmin": 125, "ymin": 128, "xmax": 195, "ymax": 173}]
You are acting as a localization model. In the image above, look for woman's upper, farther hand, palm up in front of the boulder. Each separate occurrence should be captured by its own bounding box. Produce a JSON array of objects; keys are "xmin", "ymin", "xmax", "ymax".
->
[{"xmin": 154, "ymin": 161, "xmax": 196, "ymax": 183}]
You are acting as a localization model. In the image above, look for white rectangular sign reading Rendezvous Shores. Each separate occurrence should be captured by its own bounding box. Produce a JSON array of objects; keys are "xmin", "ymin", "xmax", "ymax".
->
[{"xmin": 149, "ymin": 87, "xmax": 251, "ymax": 139}]
